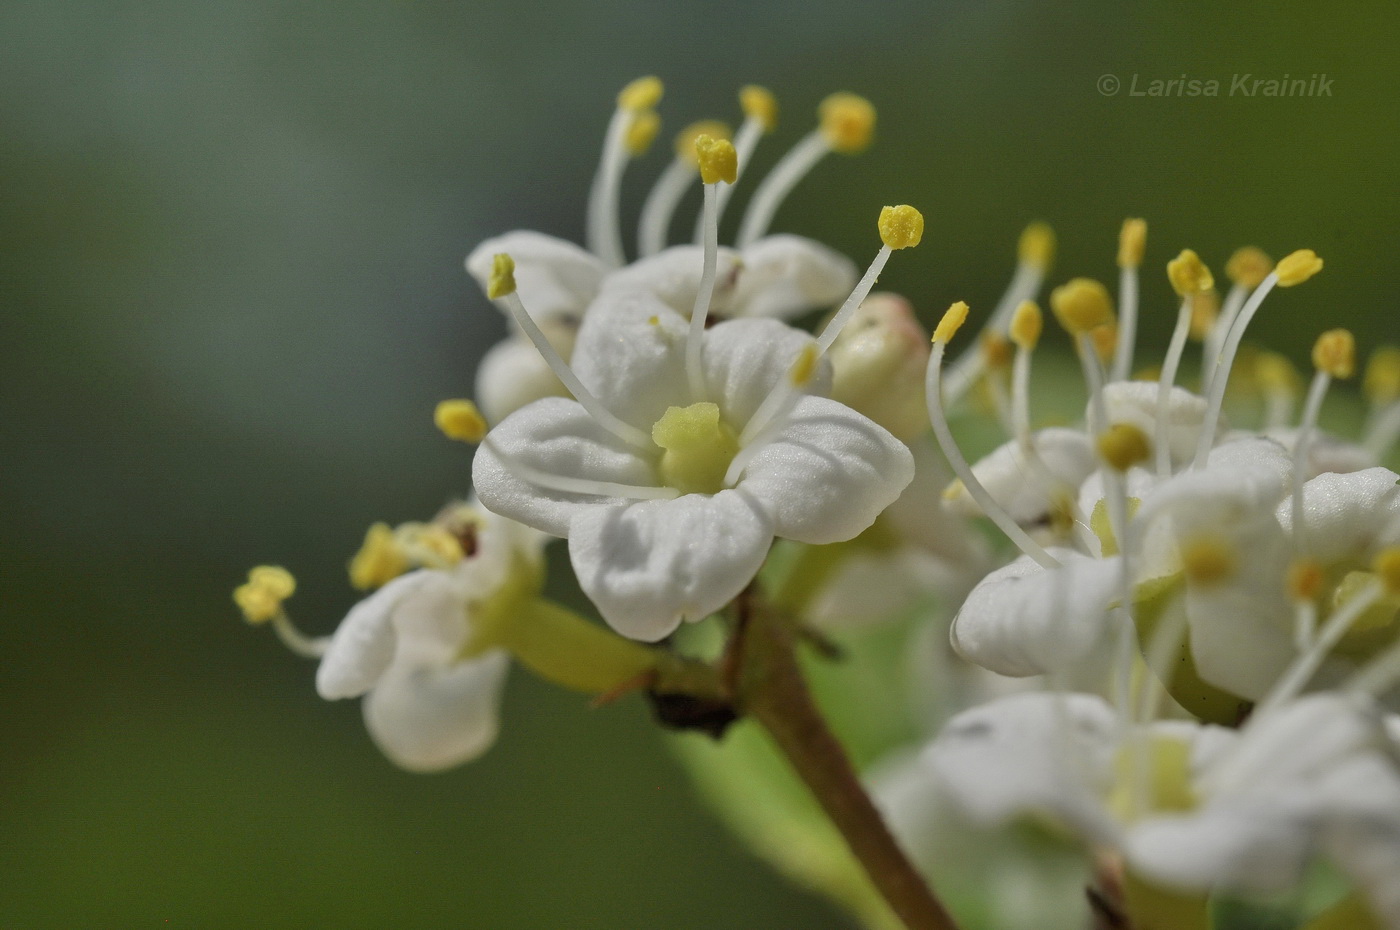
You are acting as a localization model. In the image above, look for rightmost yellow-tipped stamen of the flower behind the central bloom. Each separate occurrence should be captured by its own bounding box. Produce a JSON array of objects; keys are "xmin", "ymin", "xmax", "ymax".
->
[{"xmin": 735, "ymin": 94, "xmax": 875, "ymax": 249}]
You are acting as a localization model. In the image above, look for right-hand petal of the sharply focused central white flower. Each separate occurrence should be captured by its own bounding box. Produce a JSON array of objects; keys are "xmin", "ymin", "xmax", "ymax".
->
[{"xmin": 725, "ymin": 394, "xmax": 914, "ymax": 545}]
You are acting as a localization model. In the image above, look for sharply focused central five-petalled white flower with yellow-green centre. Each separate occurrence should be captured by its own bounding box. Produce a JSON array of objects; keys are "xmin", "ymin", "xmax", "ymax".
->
[{"xmin": 473, "ymin": 291, "xmax": 913, "ymax": 640}]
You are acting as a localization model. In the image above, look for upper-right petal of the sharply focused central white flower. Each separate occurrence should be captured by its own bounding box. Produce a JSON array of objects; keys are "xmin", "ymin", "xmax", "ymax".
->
[{"xmin": 703, "ymin": 319, "xmax": 832, "ymax": 430}]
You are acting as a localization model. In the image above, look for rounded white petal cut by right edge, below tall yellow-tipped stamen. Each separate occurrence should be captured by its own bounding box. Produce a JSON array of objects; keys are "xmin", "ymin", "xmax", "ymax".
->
[{"xmin": 1277, "ymin": 468, "xmax": 1400, "ymax": 562}]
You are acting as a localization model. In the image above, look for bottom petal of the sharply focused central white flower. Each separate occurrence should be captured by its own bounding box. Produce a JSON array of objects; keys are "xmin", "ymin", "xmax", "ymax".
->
[{"xmin": 568, "ymin": 490, "xmax": 773, "ymax": 641}]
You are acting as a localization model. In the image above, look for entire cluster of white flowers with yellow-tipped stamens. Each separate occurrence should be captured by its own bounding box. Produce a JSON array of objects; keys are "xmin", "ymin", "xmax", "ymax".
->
[{"xmin": 235, "ymin": 78, "xmax": 1400, "ymax": 927}]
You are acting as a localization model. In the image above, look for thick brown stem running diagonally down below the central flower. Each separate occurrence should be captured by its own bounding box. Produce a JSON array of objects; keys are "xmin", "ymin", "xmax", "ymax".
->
[{"xmin": 739, "ymin": 609, "xmax": 956, "ymax": 930}]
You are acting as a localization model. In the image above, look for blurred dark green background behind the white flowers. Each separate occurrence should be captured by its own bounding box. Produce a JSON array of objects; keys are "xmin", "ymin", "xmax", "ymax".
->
[{"xmin": 0, "ymin": 0, "xmax": 1400, "ymax": 929}]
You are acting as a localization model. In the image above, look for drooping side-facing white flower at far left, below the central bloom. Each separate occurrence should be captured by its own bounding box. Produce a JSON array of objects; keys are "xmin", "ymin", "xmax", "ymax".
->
[{"xmin": 316, "ymin": 513, "xmax": 543, "ymax": 772}]
